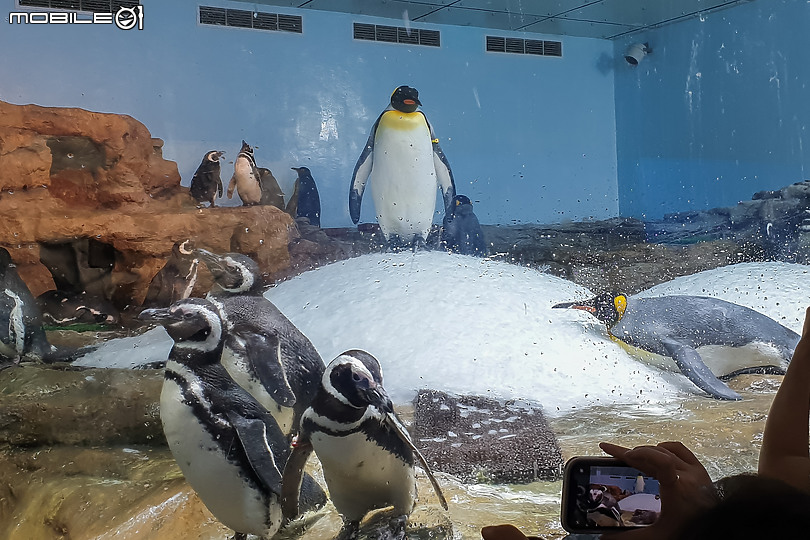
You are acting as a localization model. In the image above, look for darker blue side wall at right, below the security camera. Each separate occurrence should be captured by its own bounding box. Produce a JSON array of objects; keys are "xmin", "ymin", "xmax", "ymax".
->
[{"xmin": 614, "ymin": 0, "xmax": 810, "ymax": 218}]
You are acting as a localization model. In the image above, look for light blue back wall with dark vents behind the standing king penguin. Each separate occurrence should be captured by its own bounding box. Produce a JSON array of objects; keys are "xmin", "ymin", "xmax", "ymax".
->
[{"xmin": 0, "ymin": 0, "xmax": 619, "ymax": 226}]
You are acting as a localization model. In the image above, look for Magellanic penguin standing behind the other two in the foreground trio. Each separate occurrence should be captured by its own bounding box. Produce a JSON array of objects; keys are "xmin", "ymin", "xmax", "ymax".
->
[{"xmin": 196, "ymin": 249, "xmax": 324, "ymax": 434}]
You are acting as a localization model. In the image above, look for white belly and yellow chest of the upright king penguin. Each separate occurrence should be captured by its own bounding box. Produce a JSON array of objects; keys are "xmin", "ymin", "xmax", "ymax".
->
[{"xmin": 371, "ymin": 111, "xmax": 437, "ymax": 240}]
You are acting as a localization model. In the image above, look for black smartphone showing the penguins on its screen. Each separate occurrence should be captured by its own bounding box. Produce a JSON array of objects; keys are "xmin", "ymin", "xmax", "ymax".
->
[{"xmin": 560, "ymin": 457, "xmax": 661, "ymax": 533}]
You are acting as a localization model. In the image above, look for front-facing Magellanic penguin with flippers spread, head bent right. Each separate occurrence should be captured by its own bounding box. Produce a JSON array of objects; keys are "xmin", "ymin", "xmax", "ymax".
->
[{"xmin": 282, "ymin": 350, "xmax": 447, "ymax": 537}]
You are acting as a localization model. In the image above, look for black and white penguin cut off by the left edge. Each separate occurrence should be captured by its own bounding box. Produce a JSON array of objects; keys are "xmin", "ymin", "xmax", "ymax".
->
[{"xmin": 0, "ymin": 247, "xmax": 61, "ymax": 366}]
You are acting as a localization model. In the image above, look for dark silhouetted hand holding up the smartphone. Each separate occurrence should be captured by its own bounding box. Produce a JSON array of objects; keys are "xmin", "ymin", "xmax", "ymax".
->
[{"xmin": 599, "ymin": 442, "xmax": 718, "ymax": 540}]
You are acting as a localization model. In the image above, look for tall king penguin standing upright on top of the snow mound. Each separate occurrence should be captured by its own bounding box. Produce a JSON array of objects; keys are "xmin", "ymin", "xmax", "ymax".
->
[{"xmin": 349, "ymin": 86, "xmax": 456, "ymax": 249}]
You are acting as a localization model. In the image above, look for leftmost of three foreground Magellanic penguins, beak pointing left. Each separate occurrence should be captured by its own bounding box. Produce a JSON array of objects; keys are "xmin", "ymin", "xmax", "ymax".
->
[{"xmin": 138, "ymin": 298, "xmax": 325, "ymax": 538}]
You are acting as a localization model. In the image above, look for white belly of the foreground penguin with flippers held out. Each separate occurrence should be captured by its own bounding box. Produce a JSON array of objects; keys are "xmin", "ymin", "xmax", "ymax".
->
[{"xmin": 311, "ymin": 432, "xmax": 416, "ymax": 521}]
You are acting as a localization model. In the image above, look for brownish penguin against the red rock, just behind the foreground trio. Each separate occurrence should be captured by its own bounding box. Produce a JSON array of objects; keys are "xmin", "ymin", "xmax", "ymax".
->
[{"xmin": 142, "ymin": 240, "xmax": 200, "ymax": 308}]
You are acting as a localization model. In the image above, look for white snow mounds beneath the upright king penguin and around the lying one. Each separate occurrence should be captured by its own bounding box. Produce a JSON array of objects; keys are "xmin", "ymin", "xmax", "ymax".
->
[{"xmin": 72, "ymin": 252, "xmax": 810, "ymax": 415}]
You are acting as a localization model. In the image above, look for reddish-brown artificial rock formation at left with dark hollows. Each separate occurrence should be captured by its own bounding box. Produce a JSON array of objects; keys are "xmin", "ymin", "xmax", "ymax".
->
[{"xmin": 0, "ymin": 102, "xmax": 297, "ymax": 309}]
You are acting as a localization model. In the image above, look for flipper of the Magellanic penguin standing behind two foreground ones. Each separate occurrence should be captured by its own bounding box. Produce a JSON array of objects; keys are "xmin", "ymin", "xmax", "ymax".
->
[{"xmin": 233, "ymin": 328, "xmax": 295, "ymax": 407}]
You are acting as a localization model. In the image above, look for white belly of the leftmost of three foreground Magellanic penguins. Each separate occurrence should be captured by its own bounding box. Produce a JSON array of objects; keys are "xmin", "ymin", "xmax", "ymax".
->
[{"xmin": 160, "ymin": 362, "xmax": 281, "ymax": 537}]
